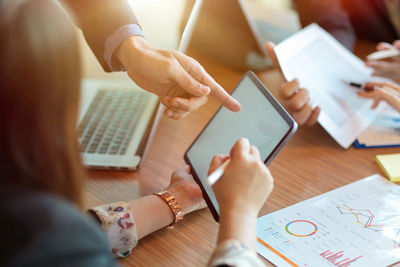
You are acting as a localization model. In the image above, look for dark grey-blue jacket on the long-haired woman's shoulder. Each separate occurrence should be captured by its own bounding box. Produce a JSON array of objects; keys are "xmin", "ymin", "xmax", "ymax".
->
[{"xmin": 0, "ymin": 188, "xmax": 116, "ymax": 267}]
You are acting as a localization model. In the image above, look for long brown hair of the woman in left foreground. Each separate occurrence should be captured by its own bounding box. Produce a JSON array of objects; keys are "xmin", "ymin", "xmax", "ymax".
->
[{"xmin": 0, "ymin": 0, "xmax": 85, "ymax": 205}]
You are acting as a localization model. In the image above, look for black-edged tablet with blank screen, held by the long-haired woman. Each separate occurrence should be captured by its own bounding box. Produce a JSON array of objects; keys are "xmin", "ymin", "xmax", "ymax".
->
[{"xmin": 184, "ymin": 72, "xmax": 297, "ymax": 221}]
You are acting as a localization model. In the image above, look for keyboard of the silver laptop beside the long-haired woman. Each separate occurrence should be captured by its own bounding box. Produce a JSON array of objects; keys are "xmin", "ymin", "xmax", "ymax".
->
[{"xmin": 78, "ymin": 89, "xmax": 148, "ymax": 155}]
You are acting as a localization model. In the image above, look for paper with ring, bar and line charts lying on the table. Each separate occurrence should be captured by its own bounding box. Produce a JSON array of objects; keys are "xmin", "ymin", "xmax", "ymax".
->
[{"xmin": 257, "ymin": 174, "xmax": 400, "ymax": 267}]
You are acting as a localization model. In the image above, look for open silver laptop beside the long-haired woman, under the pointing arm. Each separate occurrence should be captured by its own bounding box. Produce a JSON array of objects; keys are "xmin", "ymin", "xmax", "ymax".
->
[{"xmin": 78, "ymin": 0, "xmax": 201, "ymax": 171}]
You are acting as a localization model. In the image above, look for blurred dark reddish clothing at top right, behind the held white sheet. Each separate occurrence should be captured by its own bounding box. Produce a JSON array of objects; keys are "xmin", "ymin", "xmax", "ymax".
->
[{"xmin": 294, "ymin": 0, "xmax": 400, "ymax": 50}]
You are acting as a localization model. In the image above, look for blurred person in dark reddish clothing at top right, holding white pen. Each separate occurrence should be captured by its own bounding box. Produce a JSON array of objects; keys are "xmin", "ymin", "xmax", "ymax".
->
[{"xmin": 293, "ymin": 0, "xmax": 400, "ymax": 82}]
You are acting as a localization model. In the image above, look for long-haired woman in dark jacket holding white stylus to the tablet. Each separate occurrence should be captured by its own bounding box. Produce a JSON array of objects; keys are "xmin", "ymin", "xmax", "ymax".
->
[{"xmin": 0, "ymin": 0, "xmax": 273, "ymax": 267}]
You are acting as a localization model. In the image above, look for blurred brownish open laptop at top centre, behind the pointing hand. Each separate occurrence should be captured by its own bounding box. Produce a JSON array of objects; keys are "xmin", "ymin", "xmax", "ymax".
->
[{"xmin": 183, "ymin": 0, "xmax": 300, "ymax": 71}]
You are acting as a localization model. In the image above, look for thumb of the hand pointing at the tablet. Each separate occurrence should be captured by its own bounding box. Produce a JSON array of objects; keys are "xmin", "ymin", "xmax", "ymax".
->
[{"xmin": 173, "ymin": 66, "xmax": 210, "ymax": 96}]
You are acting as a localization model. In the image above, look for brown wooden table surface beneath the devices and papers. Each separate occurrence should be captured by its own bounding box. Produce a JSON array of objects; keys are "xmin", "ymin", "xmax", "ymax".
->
[{"xmin": 86, "ymin": 43, "xmax": 399, "ymax": 266}]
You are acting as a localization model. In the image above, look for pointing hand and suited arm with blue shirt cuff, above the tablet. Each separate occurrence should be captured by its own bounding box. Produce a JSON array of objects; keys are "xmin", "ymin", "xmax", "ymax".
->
[{"xmin": 59, "ymin": 0, "xmax": 240, "ymax": 119}]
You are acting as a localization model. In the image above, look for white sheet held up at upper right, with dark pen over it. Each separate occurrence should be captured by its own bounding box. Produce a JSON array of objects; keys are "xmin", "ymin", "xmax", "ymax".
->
[{"xmin": 275, "ymin": 24, "xmax": 382, "ymax": 148}]
